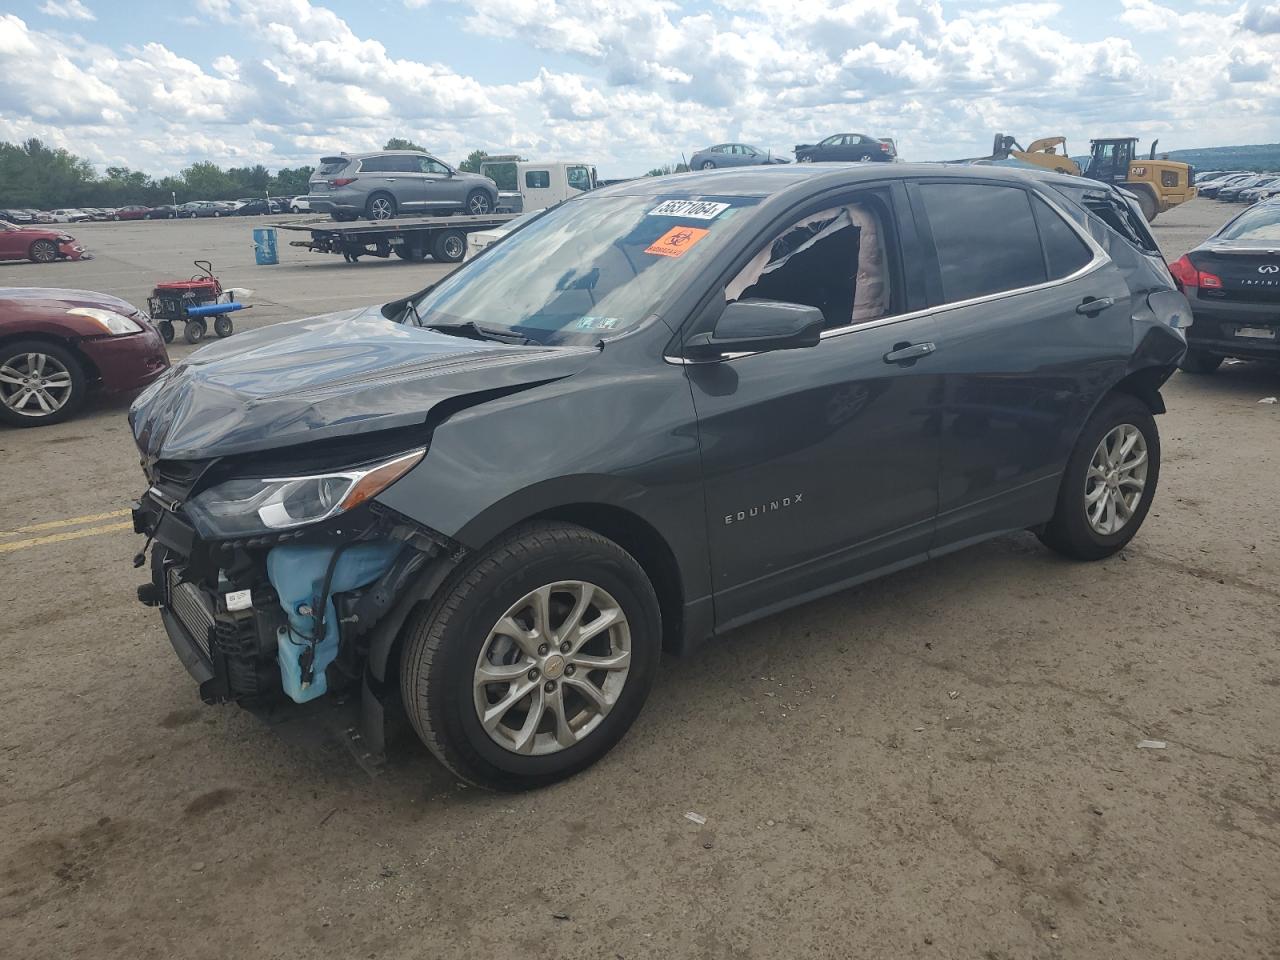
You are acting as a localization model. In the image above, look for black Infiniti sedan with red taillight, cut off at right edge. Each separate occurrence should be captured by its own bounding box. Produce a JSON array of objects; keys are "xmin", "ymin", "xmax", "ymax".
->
[{"xmin": 1169, "ymin": 200, "xmax": 1280, "ymax": 374}]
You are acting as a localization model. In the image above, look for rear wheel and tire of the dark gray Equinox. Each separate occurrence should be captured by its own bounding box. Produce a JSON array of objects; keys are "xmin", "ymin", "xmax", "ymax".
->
[{"xmin": 1039, "ymin": 393, "xmax": 1160, "ymax": 561}]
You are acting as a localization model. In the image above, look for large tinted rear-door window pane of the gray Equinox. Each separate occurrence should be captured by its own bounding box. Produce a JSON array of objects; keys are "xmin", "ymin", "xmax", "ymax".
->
[{"xmin": 919, "ymin": 183, "xmax": 1046, "ymax": 303}]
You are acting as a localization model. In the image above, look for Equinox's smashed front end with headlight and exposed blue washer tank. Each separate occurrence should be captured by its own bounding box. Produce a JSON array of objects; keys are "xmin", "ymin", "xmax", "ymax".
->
[{"xmin": 133, "ymin": 449, "xmax": 462, "ymax": 754}]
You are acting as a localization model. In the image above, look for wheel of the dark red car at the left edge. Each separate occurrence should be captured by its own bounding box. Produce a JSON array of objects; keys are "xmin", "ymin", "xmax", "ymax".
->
[{"xmin": 0, "ymin": 340, "xmax": 87, "ymax": 426}]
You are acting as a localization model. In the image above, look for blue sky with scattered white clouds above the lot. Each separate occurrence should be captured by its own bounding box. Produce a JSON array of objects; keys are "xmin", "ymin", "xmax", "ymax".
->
[{"xmin": 0, "ymin": 0, "xmax": 1280, "ymax": 177}]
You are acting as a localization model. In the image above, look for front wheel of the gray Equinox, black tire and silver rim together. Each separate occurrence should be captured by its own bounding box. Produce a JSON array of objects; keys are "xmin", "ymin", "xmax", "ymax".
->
[{"xmin": 401, "ymin": 524, "xmax": 662, "ymax": 790}]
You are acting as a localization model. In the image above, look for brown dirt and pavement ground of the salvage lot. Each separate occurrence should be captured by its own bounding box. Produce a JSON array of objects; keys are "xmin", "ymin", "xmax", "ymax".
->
[{"xmin": 0, "ymin": 201, "xmax": 1280, "ymax": 960}]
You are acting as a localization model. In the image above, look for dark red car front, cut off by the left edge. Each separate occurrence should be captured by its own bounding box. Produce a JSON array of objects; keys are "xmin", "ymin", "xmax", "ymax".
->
[{"xmin": 0, "ymin": 287, "xmax": 169, "ymax": 426}]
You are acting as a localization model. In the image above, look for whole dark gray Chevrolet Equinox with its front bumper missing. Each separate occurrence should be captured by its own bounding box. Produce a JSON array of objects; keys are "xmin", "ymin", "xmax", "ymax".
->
[{"xmin": 131, "ymin": 164, "xmax": 1189, "ymax": 790}]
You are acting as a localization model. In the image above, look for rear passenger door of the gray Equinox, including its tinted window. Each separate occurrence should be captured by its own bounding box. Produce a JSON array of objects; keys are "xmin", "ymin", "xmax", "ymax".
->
[{"xmin": 909, "ymin": 178, "xmax": 1133, "ymax": 549}]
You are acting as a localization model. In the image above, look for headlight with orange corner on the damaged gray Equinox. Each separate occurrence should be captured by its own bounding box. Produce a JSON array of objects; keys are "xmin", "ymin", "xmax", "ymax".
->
[{"xmin": 184, "ymin": 449, "xmax": 426, "ymax": 540}]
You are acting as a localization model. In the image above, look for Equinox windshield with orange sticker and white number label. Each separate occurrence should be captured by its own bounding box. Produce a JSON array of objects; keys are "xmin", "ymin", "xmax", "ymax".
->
[{"xmin": 415, "ymin": 197, "xmax": 758, "ymax": 344}]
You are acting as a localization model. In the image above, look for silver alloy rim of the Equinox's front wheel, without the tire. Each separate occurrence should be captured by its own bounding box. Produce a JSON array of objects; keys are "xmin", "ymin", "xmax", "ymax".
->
[{"xmin": 472, "ymin": 580, "xmax": 631, "ymax": 755}]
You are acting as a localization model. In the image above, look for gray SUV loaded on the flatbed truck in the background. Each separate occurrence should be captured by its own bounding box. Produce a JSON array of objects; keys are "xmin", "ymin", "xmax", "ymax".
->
[{"xmin": 306, "ymin": 150, "xmax": 498, "ymax": 220}]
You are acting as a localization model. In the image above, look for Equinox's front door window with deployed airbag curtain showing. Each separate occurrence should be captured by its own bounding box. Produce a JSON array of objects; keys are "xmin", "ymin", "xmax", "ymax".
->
[{"xmin": 724, "ymin": 192, "xmax": 895, "ymax": 330}]
